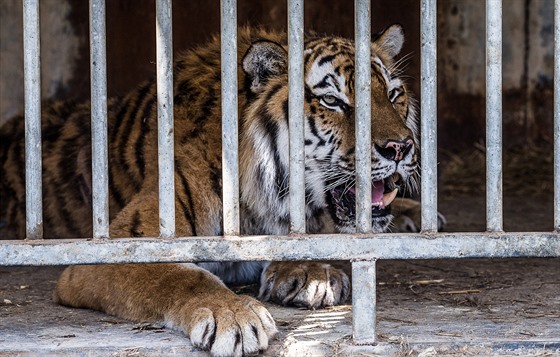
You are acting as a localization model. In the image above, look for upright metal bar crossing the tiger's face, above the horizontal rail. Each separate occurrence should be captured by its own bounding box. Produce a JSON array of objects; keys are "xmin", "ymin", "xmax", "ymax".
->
[{"xmin": 354, "ymin": 0, "xmax": 372, "ymax": 233}]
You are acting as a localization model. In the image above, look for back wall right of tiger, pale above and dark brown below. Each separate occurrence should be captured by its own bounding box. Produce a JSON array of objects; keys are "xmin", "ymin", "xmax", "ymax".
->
[{"xmin": 438, "ymin": 0, "xmax": 554, "ymax": 145}]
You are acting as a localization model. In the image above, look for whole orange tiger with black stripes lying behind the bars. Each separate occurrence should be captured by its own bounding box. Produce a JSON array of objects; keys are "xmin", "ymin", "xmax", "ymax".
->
[{"xmin": 0, "ymin": 24, "xmax": 442, "ymax": 356}]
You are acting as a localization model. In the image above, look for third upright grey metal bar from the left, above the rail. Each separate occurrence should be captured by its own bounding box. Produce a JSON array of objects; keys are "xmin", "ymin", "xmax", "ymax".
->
[{"xmin": 156, "ymin": 0, "xmax": 175, "ymax": 238}]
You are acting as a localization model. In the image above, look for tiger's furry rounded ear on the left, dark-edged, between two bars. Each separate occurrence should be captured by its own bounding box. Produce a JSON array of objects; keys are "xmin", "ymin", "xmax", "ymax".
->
[{"xmin": 243, "ymin": 40, "xmax": 288, "ymax": 93}]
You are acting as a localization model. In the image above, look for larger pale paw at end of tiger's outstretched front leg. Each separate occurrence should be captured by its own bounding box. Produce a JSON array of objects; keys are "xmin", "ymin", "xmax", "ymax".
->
[{"xmin": 181, "ymin": 296, "xmax": 278, "ymax": 357}]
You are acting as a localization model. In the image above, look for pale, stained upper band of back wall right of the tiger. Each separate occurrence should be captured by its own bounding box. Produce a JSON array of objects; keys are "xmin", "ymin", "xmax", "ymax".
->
[{"xmin": 439, "ymin": 0, "xmax": 554, "ymax": 94}]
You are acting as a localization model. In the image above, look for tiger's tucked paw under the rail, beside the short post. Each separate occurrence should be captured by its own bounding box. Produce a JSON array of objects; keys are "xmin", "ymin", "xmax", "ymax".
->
[{"xmin": 259, "ymin": 262, "xmax": 350, "ymax": 309}]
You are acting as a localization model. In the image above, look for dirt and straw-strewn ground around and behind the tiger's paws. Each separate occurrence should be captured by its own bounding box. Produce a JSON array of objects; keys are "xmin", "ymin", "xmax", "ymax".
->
[{"xmin": 0, "ymin": 149, "xmax": 560, "ymax": 357}]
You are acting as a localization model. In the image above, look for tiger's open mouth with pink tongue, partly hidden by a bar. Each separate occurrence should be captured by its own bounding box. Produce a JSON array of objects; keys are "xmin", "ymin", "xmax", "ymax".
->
[{"xmin": 329, "ymin": 178, "xmax": 398, "ymax": 226}]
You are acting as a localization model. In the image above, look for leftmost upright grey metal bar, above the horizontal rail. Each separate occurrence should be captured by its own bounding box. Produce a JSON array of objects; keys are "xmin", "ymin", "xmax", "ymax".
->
[{"xmin": 23, "ymin": 0, "xmax": 43, "ymax": 239}]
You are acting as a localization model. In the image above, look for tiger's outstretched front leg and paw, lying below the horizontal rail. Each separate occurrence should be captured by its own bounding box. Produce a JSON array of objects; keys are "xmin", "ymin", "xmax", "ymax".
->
[{"xmin": 54, "ymin": 264, "xmax": 277, "ymax": 356}]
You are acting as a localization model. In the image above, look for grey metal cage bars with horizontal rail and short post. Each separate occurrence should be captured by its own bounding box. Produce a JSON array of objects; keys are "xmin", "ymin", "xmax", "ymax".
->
[{"xmin": 0, "ymin": 0, "xmax": 560, "ymax": 344}]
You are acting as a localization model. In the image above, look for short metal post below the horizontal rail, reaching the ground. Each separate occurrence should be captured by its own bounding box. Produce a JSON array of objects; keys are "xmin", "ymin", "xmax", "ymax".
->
[{"xmin": 352, "ymin": 260, "xmax": 377, "ymax": 345}]
